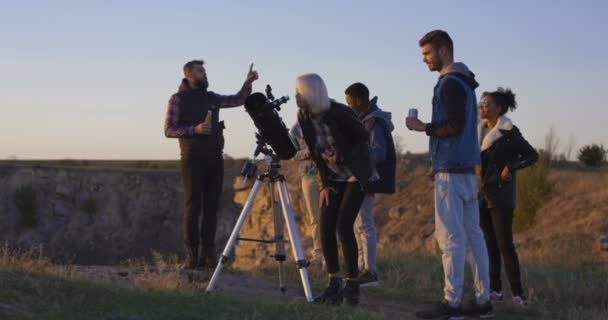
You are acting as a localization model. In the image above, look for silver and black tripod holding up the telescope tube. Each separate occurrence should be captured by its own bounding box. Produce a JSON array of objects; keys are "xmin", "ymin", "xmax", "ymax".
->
[{"xmin": 207, "ymin": 138, "xmax": 313, "ymax": 302}]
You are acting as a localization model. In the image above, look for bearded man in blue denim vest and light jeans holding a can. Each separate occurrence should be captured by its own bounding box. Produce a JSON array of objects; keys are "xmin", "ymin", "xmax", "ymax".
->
[{"xmin": 406, "ymin": 30, "xmax": 494, "ymax": 320}]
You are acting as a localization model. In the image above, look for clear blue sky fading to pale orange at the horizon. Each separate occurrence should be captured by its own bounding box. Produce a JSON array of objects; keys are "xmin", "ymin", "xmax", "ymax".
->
[{"xmin": 0, "ymin": 0, "xmax": 608, "ymax": 159}]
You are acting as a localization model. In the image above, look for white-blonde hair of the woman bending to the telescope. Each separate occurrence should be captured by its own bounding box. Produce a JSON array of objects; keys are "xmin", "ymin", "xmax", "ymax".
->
[{"xmin": 296, "ymin": 73, "xmax": 331, "ymax": 114}]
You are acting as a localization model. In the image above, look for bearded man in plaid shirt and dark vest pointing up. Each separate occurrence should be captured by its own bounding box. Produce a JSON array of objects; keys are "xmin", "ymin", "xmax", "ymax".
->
[{"xmin": 165, "ymin": 60, "xmax": 258, "ymax": 269}]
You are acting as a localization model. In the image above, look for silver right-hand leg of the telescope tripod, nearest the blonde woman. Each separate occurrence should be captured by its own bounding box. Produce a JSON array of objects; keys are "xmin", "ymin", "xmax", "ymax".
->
[{"xmin": 277, "ymin": 180, "xmax": 313, "ymax": 302}]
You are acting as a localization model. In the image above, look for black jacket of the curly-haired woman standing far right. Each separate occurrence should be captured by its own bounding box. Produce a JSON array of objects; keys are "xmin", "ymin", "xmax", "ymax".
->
[{"xmin": 480, "ymin": 121, "xmax": 538, "ymax": 209}]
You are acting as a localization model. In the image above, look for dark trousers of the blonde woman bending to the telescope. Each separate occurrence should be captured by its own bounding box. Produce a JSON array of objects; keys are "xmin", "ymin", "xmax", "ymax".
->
[{"xmin": 320, "ymin": 182, "xmax": 365, "ymax": 278}]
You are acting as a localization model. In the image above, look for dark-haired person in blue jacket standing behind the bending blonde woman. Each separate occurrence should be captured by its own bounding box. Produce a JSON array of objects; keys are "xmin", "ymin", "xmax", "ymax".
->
[{"xmin": 344, "ymin": 82, "xmax": 397, "ymax": 287}]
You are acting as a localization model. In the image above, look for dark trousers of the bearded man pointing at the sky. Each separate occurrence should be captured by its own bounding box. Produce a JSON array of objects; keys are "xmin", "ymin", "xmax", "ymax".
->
[{"xmin": 181, "ymin": 153, "xmax": 224, "ymax": 250}]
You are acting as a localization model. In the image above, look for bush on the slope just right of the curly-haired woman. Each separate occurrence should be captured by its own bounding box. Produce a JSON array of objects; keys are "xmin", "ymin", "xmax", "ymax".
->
[{"xmin": 513, "ymin": 153, "xmax": 553, "ymax": 232}]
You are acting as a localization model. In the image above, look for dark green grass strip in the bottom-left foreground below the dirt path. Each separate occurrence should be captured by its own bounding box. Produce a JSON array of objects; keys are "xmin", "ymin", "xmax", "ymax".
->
[{"xmin": 0, "ymin": 271, "xmax": 372, "ymax": 320}]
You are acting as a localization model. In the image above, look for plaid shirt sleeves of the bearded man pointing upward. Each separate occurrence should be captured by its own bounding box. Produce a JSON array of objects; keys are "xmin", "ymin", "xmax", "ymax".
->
[{"xmin": 165, "ymin": 82, "xmax": 251, "ymax": 138}]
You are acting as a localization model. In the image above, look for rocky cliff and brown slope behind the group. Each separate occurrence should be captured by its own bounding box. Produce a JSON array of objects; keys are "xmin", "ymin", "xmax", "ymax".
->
[{"xmin": 0, "ymin": 156, "xmax": 608, "ymax": 269}]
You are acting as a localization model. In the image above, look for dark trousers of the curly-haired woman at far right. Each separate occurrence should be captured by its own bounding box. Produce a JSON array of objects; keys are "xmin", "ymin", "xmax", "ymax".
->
[{"xmin": 479, "ymin": 208, "xmax": 524, "ymax": 296}]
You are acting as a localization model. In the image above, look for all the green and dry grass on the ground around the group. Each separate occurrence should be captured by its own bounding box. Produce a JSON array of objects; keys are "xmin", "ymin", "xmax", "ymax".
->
[{"xmin": 0, "ymin": 240, "xmax": 608, "ymax": 320}]
